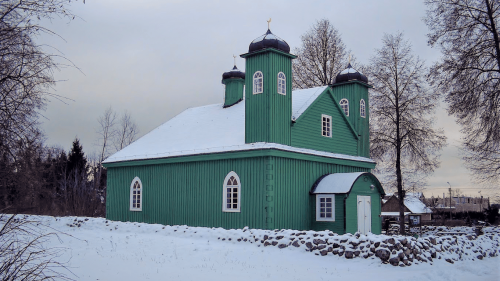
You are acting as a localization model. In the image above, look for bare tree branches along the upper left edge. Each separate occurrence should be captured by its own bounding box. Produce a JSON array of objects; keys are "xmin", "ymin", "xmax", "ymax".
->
[{"xmin": 0, "ymin": 0, "xmax": 80, "ymax": 158}]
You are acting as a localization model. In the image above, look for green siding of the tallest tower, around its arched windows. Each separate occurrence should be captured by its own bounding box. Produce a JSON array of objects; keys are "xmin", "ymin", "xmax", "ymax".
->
[{"xmin": 245, "ymin": 49, "xmax": 292, "ymax": 145}]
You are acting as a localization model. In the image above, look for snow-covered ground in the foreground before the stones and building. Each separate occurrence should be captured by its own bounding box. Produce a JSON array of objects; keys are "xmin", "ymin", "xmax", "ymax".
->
[{"xmin": 4, "ymin": 216, "xmax": 500, "ymax": 281}]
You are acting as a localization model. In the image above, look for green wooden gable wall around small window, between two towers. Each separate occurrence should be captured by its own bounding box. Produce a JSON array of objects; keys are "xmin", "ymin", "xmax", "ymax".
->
[{"xmin": 292, "ymin": 90, "xmax": 358, "ymax": 155}]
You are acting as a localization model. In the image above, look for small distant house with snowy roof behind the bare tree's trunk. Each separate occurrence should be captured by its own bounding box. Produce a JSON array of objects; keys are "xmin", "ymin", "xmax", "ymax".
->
[{"xmin": 381, "ymin": 193, "xmax": 432, "ymax": 221}]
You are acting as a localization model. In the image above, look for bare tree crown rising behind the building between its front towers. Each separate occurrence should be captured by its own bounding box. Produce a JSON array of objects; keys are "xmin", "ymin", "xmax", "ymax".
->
[{"xmin": 292, "ymin": 19, "xmax": 347, "ymax": 89}]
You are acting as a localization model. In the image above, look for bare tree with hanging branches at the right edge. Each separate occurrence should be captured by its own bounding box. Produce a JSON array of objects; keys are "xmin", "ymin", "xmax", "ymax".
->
[{"xmin": 425, "ymin": 0, "xmax": 500, "ymax": 182}]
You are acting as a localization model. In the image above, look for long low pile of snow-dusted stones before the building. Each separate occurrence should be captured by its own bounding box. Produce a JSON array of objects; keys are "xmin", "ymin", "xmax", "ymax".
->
[{"xmin": 219, "ymin": 228, "xmax": 500, "ymax": 267}]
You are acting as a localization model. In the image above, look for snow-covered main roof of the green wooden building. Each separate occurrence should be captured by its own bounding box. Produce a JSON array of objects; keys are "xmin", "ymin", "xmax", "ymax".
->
[{"xmin": 104, "ymin": 86, "xmax": 375, "ymax": 163}]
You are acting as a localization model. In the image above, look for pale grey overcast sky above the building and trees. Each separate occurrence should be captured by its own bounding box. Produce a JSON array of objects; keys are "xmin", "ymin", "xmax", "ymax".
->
[{"xmin": 35, "ymin": 0, "xmax": 492, "ymax": 201}]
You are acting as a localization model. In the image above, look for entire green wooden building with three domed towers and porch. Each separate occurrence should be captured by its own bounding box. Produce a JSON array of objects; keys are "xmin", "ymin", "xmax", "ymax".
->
[{"xmin": 100, "ymin": 30, "xmax": 384, "ymax": 234}]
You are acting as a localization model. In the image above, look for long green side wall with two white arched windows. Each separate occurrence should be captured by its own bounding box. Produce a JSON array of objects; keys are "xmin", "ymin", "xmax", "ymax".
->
[{"xmin": 106, "ymin": 157, "xmax": 266, "ymax": 228}]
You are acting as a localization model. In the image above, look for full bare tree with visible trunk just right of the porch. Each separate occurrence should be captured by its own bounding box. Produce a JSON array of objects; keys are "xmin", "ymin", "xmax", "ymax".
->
[{"xmin": 367, "ymin": 33, "xmax": 446, "ymax": 234}]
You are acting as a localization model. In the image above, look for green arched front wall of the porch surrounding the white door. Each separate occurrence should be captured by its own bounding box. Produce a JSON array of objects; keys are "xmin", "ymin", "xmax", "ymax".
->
[{"xmin": 345, "ymin": 176, "xmax": 382, "ymax": 234}]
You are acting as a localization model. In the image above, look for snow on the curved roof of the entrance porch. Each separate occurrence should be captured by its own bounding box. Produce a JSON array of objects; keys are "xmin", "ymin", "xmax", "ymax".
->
[{"xmin": 313, "ymin": 172, "xmax": 366, "ymax": 194}]
